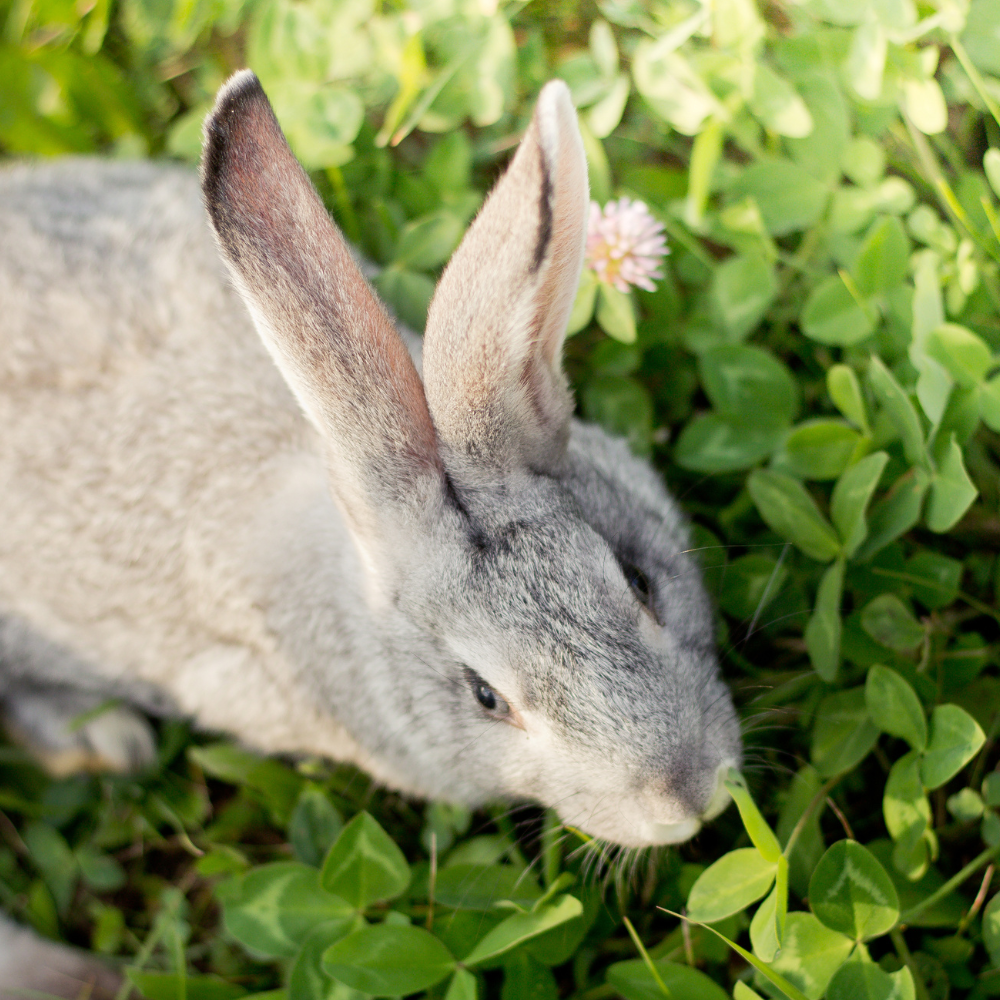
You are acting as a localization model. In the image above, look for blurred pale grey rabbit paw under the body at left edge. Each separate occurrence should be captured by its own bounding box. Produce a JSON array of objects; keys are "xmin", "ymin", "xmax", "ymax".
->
[{"xmin": 4, "ymin": 689, "xmax": 156, "ymax": 777}]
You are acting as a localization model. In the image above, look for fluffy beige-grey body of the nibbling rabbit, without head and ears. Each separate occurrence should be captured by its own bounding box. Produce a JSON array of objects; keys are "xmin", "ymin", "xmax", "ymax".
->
[{"xmin": 0, "ymin": 160, "xmax": 378, "ymax": 768}]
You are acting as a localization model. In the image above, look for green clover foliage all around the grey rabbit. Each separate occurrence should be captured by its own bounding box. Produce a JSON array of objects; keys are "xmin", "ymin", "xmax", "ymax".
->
[{"xmin": 7, "ymin": 0, "xmax": 1000, "ymax": 1000}]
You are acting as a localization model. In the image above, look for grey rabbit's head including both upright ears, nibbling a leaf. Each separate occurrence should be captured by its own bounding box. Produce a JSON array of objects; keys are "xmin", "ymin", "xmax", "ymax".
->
[{"xmin": 202, "ymin": 71, "xmax": 740, "ymax": 845}]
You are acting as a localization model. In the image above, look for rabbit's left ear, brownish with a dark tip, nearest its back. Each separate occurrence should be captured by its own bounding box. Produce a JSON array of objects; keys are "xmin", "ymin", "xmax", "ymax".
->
[{"xmin": 202, "ymin": 70, "xmax": 444, "ymax": 569}]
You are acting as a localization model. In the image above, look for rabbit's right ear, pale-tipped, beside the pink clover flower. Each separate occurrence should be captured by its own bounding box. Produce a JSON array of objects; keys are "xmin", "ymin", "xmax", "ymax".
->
[{"xmin": 424, "ymin": 80, "xmax": 589, "ymax": 478}]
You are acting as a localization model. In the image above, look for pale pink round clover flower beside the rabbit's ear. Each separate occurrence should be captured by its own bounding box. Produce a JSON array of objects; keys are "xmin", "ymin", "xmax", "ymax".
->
[{"xmin": 586, "ymin": 198, "xmax": 670, "ymax": 292}]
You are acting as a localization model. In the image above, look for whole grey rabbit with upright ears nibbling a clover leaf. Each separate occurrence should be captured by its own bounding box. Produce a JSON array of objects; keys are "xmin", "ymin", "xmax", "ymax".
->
[{"xmin": 0, "ymin": 70, "xmax": 741, "ymax": 864}]
